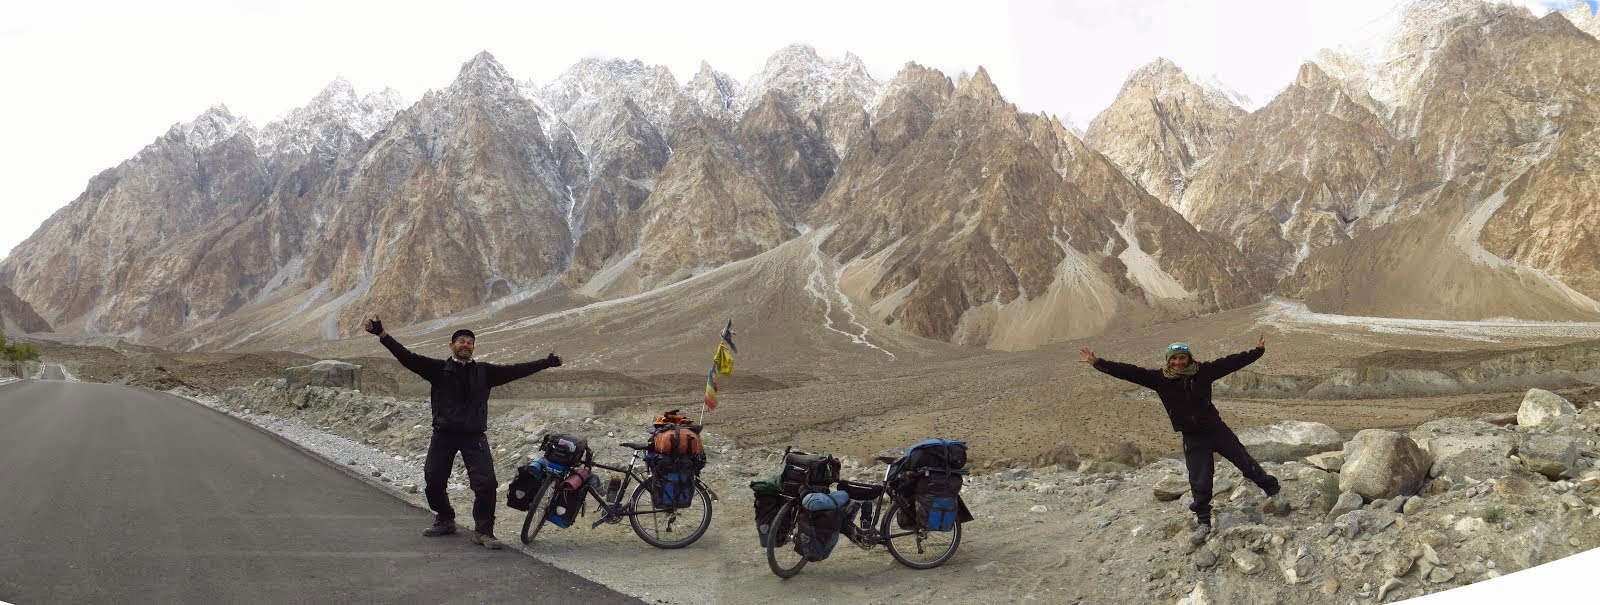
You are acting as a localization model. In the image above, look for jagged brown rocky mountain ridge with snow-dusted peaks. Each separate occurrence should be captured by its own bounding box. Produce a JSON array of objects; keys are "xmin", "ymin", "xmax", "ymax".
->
[{"xmin": 0, "ymin": 0, "xmax": 1600, "ymax": 349}]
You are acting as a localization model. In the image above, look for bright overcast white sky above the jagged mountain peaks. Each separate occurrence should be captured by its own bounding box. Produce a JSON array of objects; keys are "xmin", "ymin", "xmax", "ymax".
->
[{"xmin": 0, "ymin": 0, "xmax": 1568, "ymax": 254}]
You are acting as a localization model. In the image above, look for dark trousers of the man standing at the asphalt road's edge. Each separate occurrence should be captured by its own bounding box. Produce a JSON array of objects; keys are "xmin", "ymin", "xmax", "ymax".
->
[{"xmin": 422, "ymin": 431, "xmax": 499, "ymax": 535}]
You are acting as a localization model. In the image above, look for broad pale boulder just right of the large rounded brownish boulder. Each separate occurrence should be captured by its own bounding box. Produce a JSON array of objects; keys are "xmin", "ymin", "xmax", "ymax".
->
[{"xmin": 1410, "ymin": 418, "xmax": 1517, "ymax": 480}]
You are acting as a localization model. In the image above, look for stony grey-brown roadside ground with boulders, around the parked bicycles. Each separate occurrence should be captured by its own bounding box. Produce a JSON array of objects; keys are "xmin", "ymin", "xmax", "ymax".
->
[{"xmin": 179, "ymin": 366, "xmax": 1600, "ymax": 603}]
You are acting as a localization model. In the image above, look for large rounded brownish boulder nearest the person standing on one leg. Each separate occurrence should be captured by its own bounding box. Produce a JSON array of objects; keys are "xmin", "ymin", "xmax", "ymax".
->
[{"xmin": 1339, "ymin": 429, "xmax": 1434, "ymax": 501}]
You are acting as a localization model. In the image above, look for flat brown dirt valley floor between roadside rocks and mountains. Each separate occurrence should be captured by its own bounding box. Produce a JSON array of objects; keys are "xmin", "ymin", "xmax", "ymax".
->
[{"xmin": 31, "ymin": 304, "xmax": 1600, "ymax": 466}]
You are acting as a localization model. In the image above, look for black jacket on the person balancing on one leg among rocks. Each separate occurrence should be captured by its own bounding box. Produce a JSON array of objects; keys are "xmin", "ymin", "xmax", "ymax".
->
[{"xmin": 1094, "ymin": 347, "xmax": 1267, "ymax": 431}]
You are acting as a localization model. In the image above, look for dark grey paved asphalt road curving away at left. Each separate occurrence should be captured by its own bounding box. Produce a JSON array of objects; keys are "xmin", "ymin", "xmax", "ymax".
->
[{"xmin": 0, "ymin": 381, "xmax": 637, "ymax": 605}]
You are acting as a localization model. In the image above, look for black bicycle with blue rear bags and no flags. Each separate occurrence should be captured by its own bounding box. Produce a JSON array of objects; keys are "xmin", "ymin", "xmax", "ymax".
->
[{"xmin": 766, "ymin": 458, "xmax": 962, "ymax": 579}]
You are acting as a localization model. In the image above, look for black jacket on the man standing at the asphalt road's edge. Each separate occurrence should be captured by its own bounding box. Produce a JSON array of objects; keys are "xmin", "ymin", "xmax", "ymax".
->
[{"xmin": 379, "ymin": 335, "xmax": 552, "ymax": 432}]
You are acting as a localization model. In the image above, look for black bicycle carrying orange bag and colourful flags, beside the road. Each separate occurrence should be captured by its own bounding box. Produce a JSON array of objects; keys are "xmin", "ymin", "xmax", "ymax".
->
[{"xmin": 522, "ymin": 443, "xmax": 714, "ymax": 549}]
